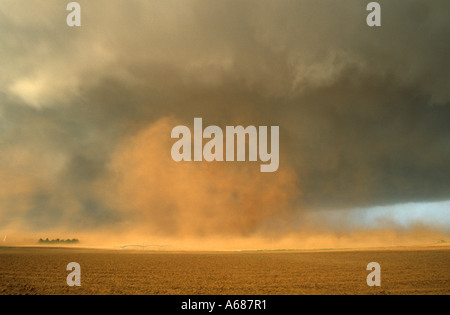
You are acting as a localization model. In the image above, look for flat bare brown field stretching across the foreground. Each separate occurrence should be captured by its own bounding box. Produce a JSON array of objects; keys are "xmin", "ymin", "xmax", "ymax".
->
[{"xmin": 0, "ymin": 245, "xmax": 450, "ymax": 295}]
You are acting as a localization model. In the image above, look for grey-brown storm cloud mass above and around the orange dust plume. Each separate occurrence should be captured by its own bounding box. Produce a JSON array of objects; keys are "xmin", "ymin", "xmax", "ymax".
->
[{"xmin": 0, "ymin": 1, "xmax": 450, "ymax": 235}]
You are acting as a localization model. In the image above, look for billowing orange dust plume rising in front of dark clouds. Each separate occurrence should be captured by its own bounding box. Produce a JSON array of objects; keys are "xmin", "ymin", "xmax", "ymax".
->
[{"xmin": 99, "ymin": 118, "xmax": 298, "ymax": 236}]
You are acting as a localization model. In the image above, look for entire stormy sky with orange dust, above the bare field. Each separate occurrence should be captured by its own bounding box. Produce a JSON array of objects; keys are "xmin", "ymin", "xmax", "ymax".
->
[{"xmin": 0, "ymin": 0, "xmax": 450, "ymax": 248}]
